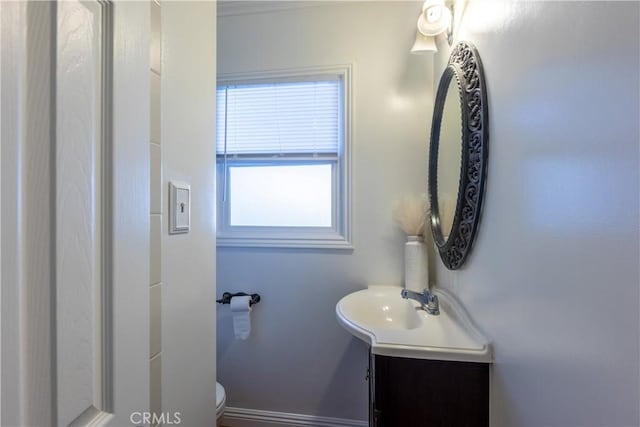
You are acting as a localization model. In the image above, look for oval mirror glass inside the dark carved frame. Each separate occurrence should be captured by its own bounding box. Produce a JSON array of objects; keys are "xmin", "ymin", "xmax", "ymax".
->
[{"xmin": 437, "ymin": 78, "xmax": 462, "ymax": 240}]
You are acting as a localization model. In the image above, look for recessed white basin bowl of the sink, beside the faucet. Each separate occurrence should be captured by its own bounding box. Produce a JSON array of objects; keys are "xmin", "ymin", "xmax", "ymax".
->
[{"xmin": 340, "ymin": 286, "xmax": 422, "ymax": 330}]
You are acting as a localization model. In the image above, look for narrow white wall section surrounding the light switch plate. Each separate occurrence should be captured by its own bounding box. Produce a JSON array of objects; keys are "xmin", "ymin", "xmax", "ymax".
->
[{"xmin": 161, "ymin": 1, "xmax": 216, "ymax": 426}]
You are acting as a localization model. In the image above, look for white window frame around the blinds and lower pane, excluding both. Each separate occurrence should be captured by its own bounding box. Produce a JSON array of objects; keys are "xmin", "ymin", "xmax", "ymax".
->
[{"xmin": 216, "ymin": 64, "xmax": 353, "ymax": 249}]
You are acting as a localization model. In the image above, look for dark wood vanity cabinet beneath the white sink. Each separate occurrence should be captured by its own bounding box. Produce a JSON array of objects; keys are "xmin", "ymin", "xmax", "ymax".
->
[{"xmin": 368, "ymin": 353, "xmax": 489, "ymax": 427}]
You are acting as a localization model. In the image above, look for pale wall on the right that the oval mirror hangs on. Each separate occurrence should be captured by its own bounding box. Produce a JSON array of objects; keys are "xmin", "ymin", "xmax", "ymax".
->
[{"xmin": 436, "ymin": 1, "xmax": 640, "ymax": 426}]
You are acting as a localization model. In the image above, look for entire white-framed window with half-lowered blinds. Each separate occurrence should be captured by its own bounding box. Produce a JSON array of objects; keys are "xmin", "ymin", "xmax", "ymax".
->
[{"xmin": 216, "ymin": 66, "xmax": 351, "ymax": 248}]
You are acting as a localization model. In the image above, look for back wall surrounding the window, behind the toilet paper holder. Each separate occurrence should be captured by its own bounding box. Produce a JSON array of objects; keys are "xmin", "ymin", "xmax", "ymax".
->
[{"xmin": 217, "ymin": 2, "xmax": 433, "ymax": 420}]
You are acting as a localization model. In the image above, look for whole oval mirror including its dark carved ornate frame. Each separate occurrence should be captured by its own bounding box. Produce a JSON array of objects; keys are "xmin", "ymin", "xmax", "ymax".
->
[{"xmin": 428, "ymin": 42, "xmax": 489, "ymax": 270}]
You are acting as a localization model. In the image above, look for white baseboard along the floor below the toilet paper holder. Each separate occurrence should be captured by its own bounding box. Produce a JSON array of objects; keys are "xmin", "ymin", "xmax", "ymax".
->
[{"xmin": 222, "ymin": 407, "xmax": 369, "ymax": 427}]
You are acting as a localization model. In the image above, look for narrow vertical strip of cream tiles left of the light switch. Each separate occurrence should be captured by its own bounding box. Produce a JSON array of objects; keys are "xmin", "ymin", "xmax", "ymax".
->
[{"xmin": 149, "ymin": 0, "xmax": 163, "ymax": 422}]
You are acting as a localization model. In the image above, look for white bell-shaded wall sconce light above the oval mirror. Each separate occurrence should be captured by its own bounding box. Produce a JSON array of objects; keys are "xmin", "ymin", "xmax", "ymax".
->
[{"xmin": 411, "ymin": 0, "xmax": 453, "ymax": 54}]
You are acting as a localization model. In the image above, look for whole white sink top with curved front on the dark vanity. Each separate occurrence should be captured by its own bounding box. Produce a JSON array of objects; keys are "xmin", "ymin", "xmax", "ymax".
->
[{"xmin": 336, "ymin": 286, "xmax": 492, "ymax": 363}]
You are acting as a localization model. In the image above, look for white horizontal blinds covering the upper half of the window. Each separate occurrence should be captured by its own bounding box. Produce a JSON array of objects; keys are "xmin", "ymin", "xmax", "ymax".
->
[{"xmin": 216, "ymin": 78, "xmax": 342, "ymax": 155}]
